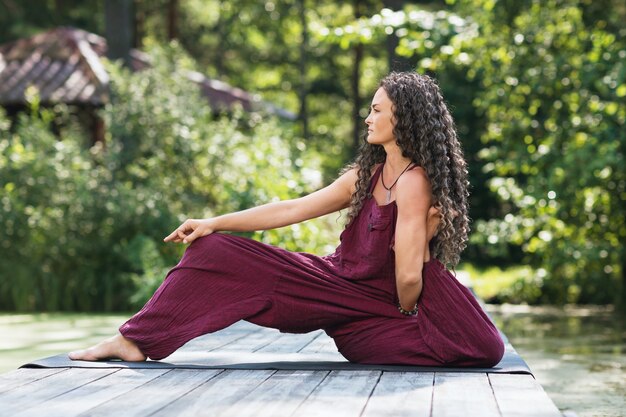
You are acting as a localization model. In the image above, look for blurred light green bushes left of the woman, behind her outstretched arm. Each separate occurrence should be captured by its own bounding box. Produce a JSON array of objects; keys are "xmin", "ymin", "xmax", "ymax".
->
[{"xmin": 0, "ymin": 48, "xmax": 338, "ymax": 311}]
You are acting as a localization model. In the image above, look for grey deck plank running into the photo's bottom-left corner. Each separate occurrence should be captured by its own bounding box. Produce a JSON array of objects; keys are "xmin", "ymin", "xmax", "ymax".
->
[{"xmin": 0, "ymin": 368, "xmax": 119, "ymax": 416}]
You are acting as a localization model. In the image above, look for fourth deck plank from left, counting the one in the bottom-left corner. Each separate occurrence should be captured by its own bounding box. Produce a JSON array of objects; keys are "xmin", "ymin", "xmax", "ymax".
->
[{"xmin": 150, "ymin": 370, "xmax": 276, "ymax": 417}]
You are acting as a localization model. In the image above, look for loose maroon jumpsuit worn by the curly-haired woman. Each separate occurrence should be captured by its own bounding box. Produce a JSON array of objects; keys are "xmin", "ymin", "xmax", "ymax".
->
[{"xmin": 120, "ymin": 165, "xmax": 504, "ymax": 367}]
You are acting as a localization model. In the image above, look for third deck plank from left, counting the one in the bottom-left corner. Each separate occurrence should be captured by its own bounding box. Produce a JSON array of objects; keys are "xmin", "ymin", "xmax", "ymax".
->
[{"xmin": 80, "ymin": 369, "xmax": 222, "ymax": 417}]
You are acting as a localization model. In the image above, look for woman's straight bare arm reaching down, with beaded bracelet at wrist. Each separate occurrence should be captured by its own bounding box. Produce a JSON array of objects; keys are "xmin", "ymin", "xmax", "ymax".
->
[{"xmin": 395, "ymin": 167, "xmax": 438, "ymax": 311}]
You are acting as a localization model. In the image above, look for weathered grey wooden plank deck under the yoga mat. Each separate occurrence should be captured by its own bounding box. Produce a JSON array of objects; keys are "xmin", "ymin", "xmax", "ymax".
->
[{"xmin": 0, "ymin": 323, "xmax": 561, "ymax": 417}]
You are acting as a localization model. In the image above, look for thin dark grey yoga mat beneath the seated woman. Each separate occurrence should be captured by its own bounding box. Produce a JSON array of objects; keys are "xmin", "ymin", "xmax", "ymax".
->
[{"xmin": 21, "ymin": 344, "xmax": 532, "ymax": 374}]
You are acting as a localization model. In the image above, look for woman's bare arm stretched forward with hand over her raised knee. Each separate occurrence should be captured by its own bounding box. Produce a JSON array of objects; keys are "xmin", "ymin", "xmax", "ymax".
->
[{"xmin": 164, "ymin": 169, "xmax": 357, "ymax": 243}]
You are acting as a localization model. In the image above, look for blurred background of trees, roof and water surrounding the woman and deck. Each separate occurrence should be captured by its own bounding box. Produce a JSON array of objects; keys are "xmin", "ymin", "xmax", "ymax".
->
[{"xmin": 0, "ymin": 0, "xmax": 626, "ymax": 416}]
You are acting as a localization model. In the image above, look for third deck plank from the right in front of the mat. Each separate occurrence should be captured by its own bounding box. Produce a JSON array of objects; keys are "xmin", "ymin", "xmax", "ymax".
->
[{"xmin": 362, "ymin": 372, "xmax": 435, "ymax": 417}]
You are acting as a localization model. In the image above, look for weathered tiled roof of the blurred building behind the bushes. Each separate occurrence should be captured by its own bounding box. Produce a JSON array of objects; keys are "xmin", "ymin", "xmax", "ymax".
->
[{"xmin": 0, "ymin": 27, "xmax": 295, "ymax": 119}]
